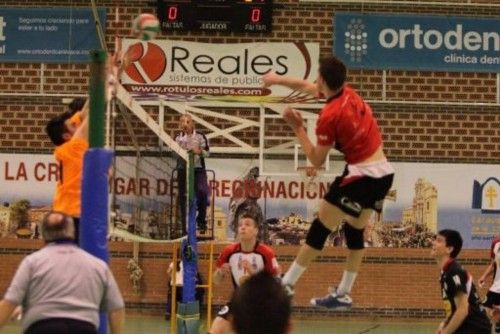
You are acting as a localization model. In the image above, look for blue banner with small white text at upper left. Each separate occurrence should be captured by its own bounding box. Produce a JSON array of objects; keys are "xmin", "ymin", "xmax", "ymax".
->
[{"xmin": 0, "ymin": 8, "xmax": 106, "ymax": 63}]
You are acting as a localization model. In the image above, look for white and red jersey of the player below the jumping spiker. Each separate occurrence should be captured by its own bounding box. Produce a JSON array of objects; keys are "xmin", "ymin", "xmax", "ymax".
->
[{"xmin": 215, "ymin": 242, "xmax": 279, "ymax": 287}]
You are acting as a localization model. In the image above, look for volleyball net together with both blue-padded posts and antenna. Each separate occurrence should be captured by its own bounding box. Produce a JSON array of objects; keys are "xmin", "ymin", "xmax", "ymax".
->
[{"xmin": 80, "ymin": 5, "xmax": 199, "ymax": 334}]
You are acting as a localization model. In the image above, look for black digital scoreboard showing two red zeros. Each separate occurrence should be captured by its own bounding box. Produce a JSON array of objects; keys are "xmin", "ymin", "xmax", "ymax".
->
[{"xmin": 158, "ymin": 0, "xmax": 273, "ymax": 33}]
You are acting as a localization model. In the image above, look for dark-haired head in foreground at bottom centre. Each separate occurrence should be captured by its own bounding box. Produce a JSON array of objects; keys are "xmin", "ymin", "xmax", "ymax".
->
[{"xmin": 231, "ymin": 270, "xmax": 291, "ymax": 334}]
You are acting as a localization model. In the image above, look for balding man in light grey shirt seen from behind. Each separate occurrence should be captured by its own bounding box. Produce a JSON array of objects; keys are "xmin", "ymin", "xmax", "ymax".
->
[{"xmin": 0, "ymin": 211, "xmax": 125, "ymax": 334}]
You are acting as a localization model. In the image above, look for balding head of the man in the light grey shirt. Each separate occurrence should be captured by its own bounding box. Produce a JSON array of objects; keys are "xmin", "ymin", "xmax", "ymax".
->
[{"xmin": 41, "ymin": 211, "xmax": 75, "ymax": 242}]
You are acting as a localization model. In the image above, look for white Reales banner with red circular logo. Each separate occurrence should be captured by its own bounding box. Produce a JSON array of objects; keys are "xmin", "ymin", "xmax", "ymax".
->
[{"xmin": 121, "ymin": 39, "xmax": 319, "ymax": 102}]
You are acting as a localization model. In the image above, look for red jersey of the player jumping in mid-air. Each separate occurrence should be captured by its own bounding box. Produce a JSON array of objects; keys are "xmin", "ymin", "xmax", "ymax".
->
[{"xmin": 316, "ymin": 85, "xmax": 382, "ymax": 164}]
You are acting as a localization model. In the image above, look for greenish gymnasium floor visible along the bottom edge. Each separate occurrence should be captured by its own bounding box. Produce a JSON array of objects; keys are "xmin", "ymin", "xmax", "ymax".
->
[{"xmin": 1, "ymin": 315, "xmax": 438, "ymax": 334}]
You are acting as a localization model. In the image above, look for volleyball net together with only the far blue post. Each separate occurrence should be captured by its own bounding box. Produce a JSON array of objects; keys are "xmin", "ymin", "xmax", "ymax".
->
[{"xmin": 109, "ymin": 84, "xmax": 200, "ymax": 333}]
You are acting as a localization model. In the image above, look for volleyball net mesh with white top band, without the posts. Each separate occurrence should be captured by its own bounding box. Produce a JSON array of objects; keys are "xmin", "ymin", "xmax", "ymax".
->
[{"xmin": 109, "ymin": 85, "xmax": 190, "ymax": 242}]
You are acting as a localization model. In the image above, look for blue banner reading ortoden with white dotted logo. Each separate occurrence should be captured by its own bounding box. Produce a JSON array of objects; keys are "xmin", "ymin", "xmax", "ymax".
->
[{"xmin": 333, "ymin": 12, "xmax": 500, "ymax": 73}]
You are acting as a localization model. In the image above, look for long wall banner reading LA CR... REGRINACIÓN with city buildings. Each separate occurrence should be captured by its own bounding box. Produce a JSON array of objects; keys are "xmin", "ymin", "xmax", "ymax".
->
[{"xmin": 0, "ymin": 154, "xmax": 500, "ymax": 248}]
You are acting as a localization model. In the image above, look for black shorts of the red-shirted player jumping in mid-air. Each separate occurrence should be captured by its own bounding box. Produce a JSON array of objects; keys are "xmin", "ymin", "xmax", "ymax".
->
[{"xmin": 324, "ymin": 166, "xmax": 394, "ymax": 218}]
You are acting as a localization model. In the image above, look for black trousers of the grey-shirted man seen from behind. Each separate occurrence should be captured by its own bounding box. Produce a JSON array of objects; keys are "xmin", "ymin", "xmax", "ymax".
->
[{"xmin": 24, "ymin": 318, "xmax": 97, "ymax": 334}]
